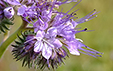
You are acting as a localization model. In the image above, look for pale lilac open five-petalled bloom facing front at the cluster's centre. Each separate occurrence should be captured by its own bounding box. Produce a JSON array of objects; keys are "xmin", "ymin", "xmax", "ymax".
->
[{"xmin": 34, "ymin": 27, "xmax": 62, "ymax": 60}]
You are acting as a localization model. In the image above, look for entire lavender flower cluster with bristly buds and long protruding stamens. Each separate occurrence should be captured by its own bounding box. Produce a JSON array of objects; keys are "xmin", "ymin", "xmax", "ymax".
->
[{"xmin": 0, "ymin": 0, "xmax": 102, "ymax": 68}]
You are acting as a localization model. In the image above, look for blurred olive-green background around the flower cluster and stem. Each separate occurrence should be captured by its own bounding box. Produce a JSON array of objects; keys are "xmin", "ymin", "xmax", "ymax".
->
[{"xmin": 0, "ymin": 0, "xmax": 113, "ymax": 71}]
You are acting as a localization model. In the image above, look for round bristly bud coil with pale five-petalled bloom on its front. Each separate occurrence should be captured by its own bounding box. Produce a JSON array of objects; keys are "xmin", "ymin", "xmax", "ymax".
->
[{"xmin": 12, "ymin": 30, "xmax": 67, "ymax": 69}]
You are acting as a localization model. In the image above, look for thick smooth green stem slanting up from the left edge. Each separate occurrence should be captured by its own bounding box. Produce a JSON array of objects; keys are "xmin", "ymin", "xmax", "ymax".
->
[{"xmin": 0, "ymin": 21, "xmax": 27, "ymax": 58}]
